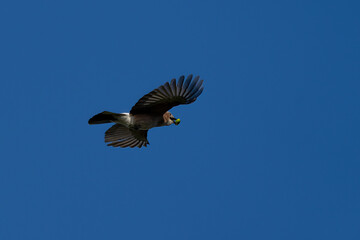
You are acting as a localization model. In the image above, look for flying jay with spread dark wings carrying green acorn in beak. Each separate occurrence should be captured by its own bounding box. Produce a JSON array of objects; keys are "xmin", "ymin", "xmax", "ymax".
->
[{"xmin": 88, "ymin": 74, "xmax": 204, "ymax": 148}]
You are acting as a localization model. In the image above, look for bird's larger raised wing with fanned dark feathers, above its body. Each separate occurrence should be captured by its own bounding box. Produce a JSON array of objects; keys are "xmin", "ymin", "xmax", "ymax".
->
[{"xmin": 130, "ymin": 74, "xmax": 204, "ymax": 115}]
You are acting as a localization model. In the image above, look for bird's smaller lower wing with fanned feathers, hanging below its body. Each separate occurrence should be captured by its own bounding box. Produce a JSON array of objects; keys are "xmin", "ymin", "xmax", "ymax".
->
[{"xmin": 105, "ymin": 124, "xmax": 150, "ymax": 148}]
